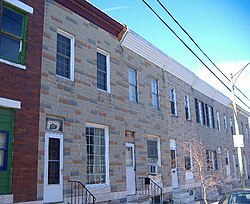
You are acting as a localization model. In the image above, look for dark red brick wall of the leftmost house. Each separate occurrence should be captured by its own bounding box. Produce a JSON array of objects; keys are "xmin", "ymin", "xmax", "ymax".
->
[{"xmin": 0, "ymin": 0, "xmax": 44, "ymax": 202}]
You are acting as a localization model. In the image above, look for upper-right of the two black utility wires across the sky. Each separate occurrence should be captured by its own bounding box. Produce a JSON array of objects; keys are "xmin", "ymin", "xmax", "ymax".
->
[{"xmin": 157, "ymin": 0, "xmax": 250, "ymax": 101}]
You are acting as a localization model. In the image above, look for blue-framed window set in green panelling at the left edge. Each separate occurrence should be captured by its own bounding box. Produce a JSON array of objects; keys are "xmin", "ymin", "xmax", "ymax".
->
[{"xmin": 0, "ymin": 132, "xmax": 9, "ymax": 171}]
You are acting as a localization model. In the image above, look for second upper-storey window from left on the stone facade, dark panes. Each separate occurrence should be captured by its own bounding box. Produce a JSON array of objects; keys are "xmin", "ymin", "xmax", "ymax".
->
[{"xmin": 97, "ymin": 49, "xmax": 110, "ymax": 92}]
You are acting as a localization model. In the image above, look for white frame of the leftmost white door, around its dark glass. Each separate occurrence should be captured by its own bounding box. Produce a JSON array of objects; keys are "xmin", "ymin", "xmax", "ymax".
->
[{"xmin": 43, "ymin": 132, "xmax": 63, "ymax": 203}]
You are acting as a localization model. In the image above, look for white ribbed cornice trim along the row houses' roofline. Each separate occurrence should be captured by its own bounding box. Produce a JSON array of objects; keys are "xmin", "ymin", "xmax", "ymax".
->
[{"xmin": 120, "ymin": 29, "xmax": 250, "ymax": 111}]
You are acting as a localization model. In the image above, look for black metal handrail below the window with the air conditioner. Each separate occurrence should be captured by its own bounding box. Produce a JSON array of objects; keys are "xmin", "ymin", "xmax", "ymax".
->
[{"xmin": 139, "ymin": 177, "xmax": 163, "ymax": 204}]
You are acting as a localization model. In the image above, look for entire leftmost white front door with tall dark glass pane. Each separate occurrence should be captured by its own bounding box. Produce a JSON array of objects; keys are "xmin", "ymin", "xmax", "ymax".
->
[{"xmin": 43, "ymin": 132, "xmax": 63, "ymax": 203}]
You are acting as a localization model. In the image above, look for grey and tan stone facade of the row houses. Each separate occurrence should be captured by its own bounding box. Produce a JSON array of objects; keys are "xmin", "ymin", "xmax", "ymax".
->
[{"xmin": 37, "ymin": 1, "xmax": 248, "ymax": 203}]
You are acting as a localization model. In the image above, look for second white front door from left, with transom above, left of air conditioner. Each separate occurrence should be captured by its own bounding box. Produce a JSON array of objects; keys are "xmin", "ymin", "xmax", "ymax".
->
[{"xmin": 126, "ymin": 143, "xmax": 136, "ymax": 195}]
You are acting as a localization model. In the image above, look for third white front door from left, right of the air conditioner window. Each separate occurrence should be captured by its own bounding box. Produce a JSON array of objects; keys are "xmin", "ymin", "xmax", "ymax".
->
[{"xmin": 170, "ymin": 140, "xmax": 179, "ymax": 188}]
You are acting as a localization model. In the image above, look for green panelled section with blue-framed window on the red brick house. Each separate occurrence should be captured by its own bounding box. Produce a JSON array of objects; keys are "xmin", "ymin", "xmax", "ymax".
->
[{"xmin": 0, "ymin": 108, "xmax": 14, "ymax": 195}]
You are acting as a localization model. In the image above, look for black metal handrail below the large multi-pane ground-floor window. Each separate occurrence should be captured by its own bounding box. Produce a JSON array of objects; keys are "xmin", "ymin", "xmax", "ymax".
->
[{"xmin": 68, "ymin": 180, "xmax": 96, "ymax": 204}]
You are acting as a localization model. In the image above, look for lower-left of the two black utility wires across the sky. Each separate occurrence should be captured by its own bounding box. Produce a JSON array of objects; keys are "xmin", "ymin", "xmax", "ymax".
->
[{"xmin": 142, "ymin": 0, "xmax": 250, "ymax": 109}]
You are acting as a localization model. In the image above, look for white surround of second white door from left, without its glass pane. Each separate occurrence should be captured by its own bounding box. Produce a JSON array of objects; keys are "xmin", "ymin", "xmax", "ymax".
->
[{"xmin": 125, "ymin": 143, "xmax": 136, "ymax": 195}]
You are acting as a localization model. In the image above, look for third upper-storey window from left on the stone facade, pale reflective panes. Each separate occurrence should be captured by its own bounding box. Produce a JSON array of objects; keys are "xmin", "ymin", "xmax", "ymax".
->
[{"xmin": 128, "ymin": 68, "xmax": 138, "ymax": 103}]
